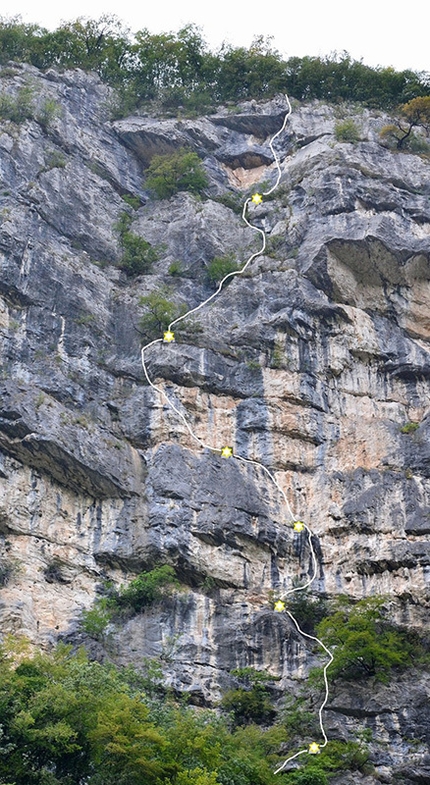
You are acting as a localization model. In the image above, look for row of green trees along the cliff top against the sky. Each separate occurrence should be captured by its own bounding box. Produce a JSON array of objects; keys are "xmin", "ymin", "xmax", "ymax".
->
[{"xmin": 0, "ymin": 16, "xmax": 430, "ymax": 114}]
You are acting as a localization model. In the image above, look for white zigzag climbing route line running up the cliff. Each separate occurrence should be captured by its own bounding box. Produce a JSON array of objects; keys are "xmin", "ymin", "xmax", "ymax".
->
[{"xmin": 141, "ymin": 95, "xmax": 333, "ymax": 774}]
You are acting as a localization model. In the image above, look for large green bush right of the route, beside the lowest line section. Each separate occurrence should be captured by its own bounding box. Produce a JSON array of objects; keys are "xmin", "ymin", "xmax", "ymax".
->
[{"xmin": 316, "ymin": 597, "xmax": 413, "ymax": 681}]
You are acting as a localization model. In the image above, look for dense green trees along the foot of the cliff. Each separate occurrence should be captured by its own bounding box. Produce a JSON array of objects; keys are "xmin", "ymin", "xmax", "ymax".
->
[{"xmin": 0, "ymin": 641, "xmax": 367, "ymax": 785}]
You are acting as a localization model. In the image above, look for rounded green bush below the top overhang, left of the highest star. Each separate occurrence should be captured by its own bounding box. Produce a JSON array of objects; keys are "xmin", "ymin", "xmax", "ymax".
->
[{"xmin": 146, "ymin": 148, "xmax": 208, "ymax": 199}]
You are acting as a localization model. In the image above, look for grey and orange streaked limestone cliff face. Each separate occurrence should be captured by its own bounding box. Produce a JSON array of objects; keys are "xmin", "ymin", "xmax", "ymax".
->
[{"xmin": 0, "ymin": 66, "xmax": 430, "ymax": 783}]
